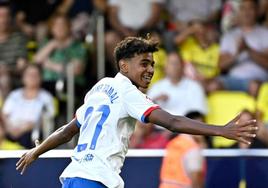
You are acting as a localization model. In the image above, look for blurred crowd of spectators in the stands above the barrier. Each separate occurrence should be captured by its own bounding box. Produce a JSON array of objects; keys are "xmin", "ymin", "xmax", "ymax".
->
[{"xmin": 0, "ymin": 0, "xmax": 268, "ymax": 156}]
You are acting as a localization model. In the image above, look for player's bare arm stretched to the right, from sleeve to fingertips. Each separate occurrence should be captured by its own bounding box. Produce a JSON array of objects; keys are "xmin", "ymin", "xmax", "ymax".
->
[{"xmin": 148, "ymin": 109, "xmax": 258, "ymax": 144}]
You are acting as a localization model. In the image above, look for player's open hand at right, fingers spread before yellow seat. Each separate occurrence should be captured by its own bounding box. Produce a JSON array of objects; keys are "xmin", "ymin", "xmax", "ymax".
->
[{"xmin": 222, "ymin": 114, "xmax": 258, "ymax": 145}]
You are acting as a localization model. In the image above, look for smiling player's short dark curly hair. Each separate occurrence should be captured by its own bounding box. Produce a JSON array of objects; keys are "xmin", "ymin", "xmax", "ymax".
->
[{"xmin": 114, "ymin": 37, "xmax": 158, "ymax": 70}]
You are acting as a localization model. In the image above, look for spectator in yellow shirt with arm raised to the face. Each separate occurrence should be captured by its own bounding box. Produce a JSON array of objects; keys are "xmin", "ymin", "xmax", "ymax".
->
[{"xmin": 176, "ymin": 20, "xmax": 219, "ymax": 92}]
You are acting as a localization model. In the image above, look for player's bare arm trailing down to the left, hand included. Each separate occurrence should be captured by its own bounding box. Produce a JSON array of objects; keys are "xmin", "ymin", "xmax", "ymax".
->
[{"xmin": 16, "ymin": 118, "xmax": 79, "ymax": 174}]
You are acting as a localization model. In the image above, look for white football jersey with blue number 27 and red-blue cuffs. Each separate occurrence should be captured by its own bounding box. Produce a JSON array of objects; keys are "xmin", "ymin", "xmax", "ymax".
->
[{"xmin": 60, "ymin": 73, "xmax": 159, "ymax": 188}]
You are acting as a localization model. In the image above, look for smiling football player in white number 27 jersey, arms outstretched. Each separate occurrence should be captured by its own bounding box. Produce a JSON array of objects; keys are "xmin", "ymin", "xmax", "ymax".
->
[{"xmin": 16, "ymin": 37, "xmax": 258, "ymax": 188}]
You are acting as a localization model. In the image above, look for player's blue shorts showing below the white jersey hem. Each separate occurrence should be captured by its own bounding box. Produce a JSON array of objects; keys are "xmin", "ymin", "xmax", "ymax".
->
[{"xmin": 62, "ymin": 177, "xmax": 107, "ymax": 188}]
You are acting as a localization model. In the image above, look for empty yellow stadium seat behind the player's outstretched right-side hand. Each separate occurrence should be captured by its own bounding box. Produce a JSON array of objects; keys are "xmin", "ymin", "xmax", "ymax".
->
[{"xmin": 206, "ymin": 91, "xmax": 256, "ymax": 148}]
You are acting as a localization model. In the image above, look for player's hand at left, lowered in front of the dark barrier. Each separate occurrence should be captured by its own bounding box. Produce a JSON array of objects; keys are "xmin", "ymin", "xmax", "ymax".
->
[{"xmin": 16, "ymin": 140, "xmax": 39, "ymax": 175}]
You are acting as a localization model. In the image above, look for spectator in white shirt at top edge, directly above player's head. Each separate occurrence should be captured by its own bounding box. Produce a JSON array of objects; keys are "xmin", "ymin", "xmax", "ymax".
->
[{"xmin": 109, "ymin": 0, "xmax": 163, "ymax": 37}]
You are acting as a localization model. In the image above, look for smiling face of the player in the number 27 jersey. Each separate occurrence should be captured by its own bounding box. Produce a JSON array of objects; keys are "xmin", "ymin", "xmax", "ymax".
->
[{"xmin": 126, "ymin": 53, "xmax": 154, "ymax": 88}]
